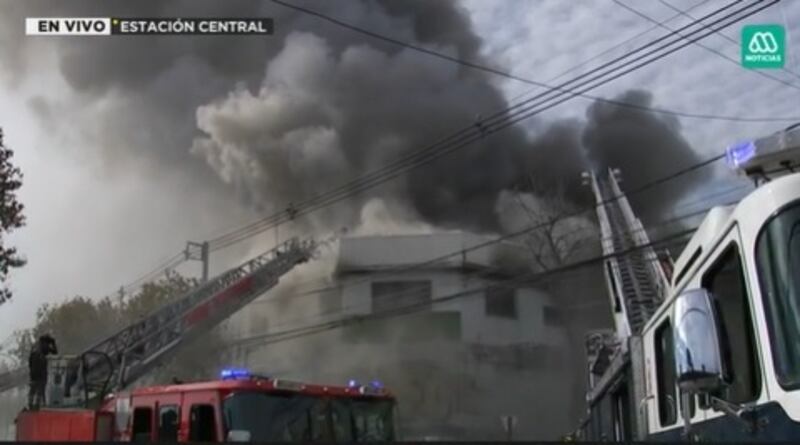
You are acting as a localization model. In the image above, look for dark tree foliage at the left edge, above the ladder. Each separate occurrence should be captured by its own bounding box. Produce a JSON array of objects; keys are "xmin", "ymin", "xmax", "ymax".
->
[{"xmin": 0, "ymin": 128, "xmax": 25, "ymax": 304}]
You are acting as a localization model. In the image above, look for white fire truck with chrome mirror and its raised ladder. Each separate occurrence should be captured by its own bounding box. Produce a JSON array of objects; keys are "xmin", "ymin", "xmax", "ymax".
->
[{"xmin": 572, "ymin": 124, "xmax": 800, "ymax": 442}]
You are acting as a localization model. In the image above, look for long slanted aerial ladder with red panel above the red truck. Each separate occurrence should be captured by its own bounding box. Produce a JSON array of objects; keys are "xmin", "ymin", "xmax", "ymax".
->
[{"xmin": 0, "ymin": 238, "xmax": 317, "ymax": 406}]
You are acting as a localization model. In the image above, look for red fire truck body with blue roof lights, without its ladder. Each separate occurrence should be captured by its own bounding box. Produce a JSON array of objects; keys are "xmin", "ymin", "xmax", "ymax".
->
[{"xmin": 17, "ymin": 370, "xmax": 395, "ymax": 443}]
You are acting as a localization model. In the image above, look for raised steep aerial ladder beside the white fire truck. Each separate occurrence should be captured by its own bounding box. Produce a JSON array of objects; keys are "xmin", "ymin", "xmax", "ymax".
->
[{"xmin": 584, "ymin": 169, "xmax": 672, "ymax": 398}]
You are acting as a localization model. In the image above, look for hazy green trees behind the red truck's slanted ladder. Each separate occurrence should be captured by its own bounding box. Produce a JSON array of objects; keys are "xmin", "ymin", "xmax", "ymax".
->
[{"xmin": 10, "ymin": 272, "xmax": 224, "ymax": 381}]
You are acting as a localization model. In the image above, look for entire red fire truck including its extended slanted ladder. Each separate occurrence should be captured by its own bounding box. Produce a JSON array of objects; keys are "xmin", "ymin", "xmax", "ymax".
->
[{"xmin": 0, "ymin": 239, "xmax": 395, "ymax": 442}]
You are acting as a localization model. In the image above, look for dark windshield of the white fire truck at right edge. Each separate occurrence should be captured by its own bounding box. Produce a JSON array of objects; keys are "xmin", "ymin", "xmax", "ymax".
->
[{"xmin": 756, "ymin": 202, "xmax": 800, "ymax": 389}]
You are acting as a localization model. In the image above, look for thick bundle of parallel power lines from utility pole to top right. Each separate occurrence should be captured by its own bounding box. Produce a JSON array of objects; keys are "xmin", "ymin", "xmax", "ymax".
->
[{"xmin": 211, "ymin": 0, "xmax": 777, "ymax": 250}]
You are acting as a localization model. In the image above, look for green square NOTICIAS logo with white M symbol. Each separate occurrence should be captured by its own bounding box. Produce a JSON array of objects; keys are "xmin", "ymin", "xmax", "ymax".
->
[{"xmin": 742, "ymin": 25, "xmax": 786, "ymax": 68}]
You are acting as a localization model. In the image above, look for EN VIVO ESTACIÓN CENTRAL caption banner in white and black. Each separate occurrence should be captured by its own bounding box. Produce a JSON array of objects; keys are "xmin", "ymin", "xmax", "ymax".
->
[{"xmin": 25, "ymin": 17, "xmax": 274, "ymax": 36}]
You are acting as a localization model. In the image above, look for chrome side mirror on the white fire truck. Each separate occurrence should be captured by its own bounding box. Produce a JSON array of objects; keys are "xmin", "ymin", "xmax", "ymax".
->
[{"xmin": 672, "ymin": 289, "xmax": 723, "ymax": 394}]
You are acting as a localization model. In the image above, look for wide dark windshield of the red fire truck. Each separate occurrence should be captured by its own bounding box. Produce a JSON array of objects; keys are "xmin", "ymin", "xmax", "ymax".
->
[{"xmin": 223, "ymin": 391, "xmax": 394, "ymax": 442}]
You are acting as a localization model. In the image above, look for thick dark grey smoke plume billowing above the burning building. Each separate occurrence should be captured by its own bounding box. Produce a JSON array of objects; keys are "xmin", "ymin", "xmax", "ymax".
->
[{"xmin": 0, "ymin": 1, "xmax": 694, "ymax": 231}]
